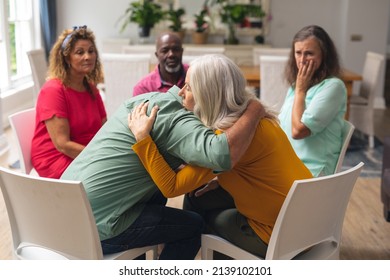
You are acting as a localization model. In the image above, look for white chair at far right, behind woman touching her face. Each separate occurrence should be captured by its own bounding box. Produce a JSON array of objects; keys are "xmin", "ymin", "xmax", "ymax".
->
[{"xmin": 349, "ymin": 52, "xmax": 385, "ymax": 148}]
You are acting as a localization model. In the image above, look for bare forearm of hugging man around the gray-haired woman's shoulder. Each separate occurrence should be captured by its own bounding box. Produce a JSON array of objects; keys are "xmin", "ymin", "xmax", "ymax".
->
[{"xmin": 225, "ymin": 100, "xmax": 266, "ymax": 167}]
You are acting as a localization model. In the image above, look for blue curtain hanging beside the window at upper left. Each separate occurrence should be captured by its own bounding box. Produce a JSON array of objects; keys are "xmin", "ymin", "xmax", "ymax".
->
[{"xmin": 39, "ymin": 0, "xmax": 57, "ymax": 59}]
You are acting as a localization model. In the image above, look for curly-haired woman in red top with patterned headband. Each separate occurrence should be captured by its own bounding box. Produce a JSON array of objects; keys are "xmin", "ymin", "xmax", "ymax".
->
[{"xmin": 31, "ymin": 26, "xmax": 107, "ymax": 179}]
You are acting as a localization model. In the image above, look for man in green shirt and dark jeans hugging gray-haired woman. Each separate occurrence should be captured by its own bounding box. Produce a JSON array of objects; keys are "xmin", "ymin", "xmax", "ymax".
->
[{"xmin": 61, "ymin": 86, "xmax": 264, "ymax": 259}]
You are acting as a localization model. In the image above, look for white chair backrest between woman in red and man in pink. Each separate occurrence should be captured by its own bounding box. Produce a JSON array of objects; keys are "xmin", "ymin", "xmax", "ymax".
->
[{"xmin": 101, "ymin": 53, "xmax": 150, "ymax": 117}]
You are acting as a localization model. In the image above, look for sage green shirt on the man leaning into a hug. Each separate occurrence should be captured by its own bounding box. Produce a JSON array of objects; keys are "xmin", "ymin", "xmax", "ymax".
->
[{"xmin": 61, "ymin": 87, "xmax": 231, "ymax": 240}]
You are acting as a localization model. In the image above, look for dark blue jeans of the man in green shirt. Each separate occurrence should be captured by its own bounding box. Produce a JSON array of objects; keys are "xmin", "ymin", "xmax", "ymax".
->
[{"xmin": 101, "ymin": 192, "xmax": 204, "ymax": 260}]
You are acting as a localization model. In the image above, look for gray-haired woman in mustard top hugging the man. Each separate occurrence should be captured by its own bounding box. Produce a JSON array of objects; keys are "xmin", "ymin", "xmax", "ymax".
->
[{"xmin": 129, "ymin": 55, "xmax": 312, "ymax": 257}]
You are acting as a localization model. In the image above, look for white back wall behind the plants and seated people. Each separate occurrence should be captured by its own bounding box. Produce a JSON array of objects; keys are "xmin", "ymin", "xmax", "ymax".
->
[{"xmin": 57, "ymin": 0, "xmax": 390, "ymax": 107}]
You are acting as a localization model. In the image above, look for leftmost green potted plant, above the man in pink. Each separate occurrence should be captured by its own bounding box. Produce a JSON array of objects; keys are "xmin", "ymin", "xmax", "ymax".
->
[{"xmin": 120, "ymin": 0, "xmax": 164, "ymax": 37}]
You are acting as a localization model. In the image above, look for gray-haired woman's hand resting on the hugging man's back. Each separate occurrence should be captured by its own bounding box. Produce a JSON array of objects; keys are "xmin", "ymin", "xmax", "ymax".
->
[{"xmin": 127, "ymin": 102, "xmax": 158, "ymax": 142}]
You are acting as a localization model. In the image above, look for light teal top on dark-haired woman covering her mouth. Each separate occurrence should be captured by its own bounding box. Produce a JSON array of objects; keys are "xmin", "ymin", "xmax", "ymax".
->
[{"xmin": 279, "ymin": 78, "xmax": 347, "ymax": 177}]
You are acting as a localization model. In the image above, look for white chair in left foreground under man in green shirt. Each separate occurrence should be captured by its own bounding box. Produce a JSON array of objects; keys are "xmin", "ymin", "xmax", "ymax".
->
[{"xmin": 0, "ymin": 167, "xmax": 157, "ymax": 260}]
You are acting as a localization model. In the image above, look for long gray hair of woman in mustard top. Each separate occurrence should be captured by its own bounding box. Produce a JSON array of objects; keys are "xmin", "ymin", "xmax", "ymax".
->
[{"xmin": 189, "ymin": 54, "xmax": 277, "ymax": 130}]
